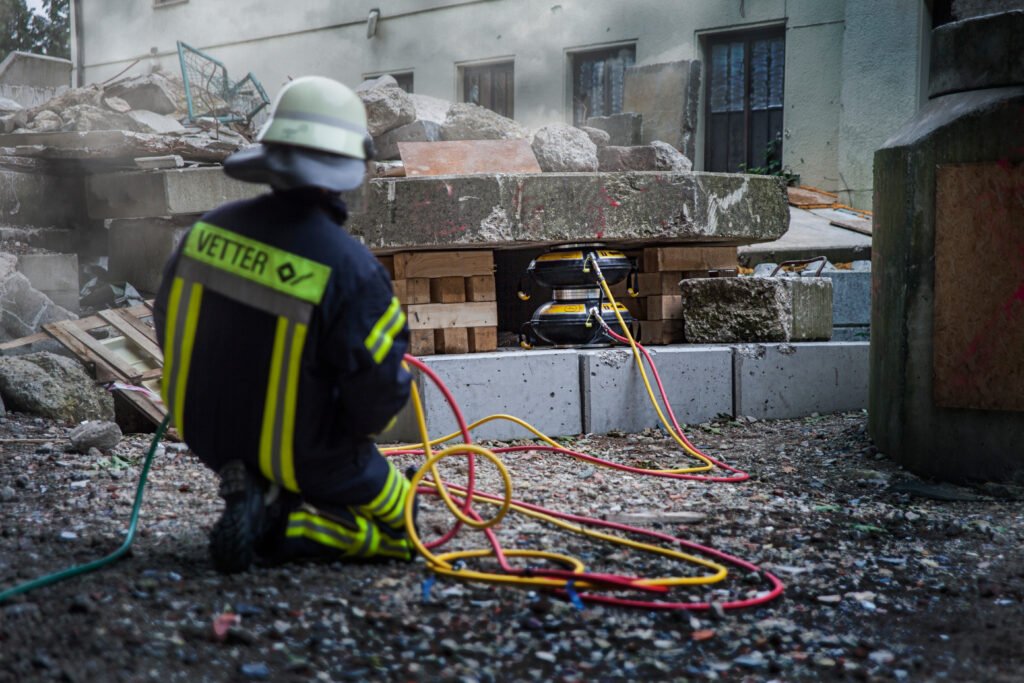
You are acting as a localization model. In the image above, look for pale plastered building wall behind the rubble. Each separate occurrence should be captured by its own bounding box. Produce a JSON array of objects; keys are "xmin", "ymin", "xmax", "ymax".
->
[{"xmin": 70, "ymin": 0, "xmax": 920, "ymax": 208}]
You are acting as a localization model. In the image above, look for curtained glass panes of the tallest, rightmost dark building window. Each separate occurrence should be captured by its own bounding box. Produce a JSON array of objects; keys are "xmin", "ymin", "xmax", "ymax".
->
[{"xmin": 705, "ymin": 30, "xmax": 785, "ymax": 173}]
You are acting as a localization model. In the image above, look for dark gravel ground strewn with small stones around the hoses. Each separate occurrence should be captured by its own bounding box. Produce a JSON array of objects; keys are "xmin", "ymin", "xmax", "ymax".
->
[{"xmin": 0, "ymin": 413, "xmax": 1024, "ymax": 681}]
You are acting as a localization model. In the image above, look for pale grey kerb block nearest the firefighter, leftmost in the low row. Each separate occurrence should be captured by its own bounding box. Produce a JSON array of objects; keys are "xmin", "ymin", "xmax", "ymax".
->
[{"xmin": 379, "ymin": 350, "xmax": 583, "ymax": 442}]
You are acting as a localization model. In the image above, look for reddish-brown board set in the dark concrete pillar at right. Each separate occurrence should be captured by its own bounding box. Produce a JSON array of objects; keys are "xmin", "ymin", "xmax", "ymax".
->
[{"xmin": 933, "ymin": 163, "xmax": 1024, "ymax": 411}]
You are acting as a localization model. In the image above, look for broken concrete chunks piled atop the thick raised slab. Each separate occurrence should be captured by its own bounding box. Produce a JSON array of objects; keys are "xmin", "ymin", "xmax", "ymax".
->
[{"xmin": 355, "ymin": 76, "xmax": 692, "ymax": 175}]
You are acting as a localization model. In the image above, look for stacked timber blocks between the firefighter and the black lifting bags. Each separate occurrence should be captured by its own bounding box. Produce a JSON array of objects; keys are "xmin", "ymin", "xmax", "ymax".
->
[{"xmin": 377, "ymin": 250, "xmax": 498, "ymax": 355}]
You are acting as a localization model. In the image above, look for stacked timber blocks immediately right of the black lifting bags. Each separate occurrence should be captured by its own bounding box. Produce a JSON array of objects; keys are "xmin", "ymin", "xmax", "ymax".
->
[{"xmin": 611, "ymin": 247, "xmax": 738, "ymax": 344}]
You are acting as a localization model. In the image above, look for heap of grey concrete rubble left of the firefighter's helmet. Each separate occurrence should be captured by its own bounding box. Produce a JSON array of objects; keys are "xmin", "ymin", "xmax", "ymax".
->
[{"xmin": 0, "ymin": 72, "xmax": 253, "ymax": 163}]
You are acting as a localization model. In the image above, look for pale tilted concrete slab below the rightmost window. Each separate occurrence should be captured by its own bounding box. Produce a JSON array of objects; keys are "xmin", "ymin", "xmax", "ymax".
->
[{"xmin": 737, "ymin": 207, "xmax": 871, "ymax": 267}]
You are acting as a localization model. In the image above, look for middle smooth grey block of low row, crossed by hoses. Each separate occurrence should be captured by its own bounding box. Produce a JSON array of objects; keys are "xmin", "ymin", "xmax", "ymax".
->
[{"xmin": 580, "ymin": 346, "xmax": 732, "ymax": 434}]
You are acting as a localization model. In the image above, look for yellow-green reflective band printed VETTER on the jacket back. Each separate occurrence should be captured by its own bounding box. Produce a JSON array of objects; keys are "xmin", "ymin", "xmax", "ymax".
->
[{"xmin": 184, "ymin": 221, "xmax": 331, "ymax": 304}]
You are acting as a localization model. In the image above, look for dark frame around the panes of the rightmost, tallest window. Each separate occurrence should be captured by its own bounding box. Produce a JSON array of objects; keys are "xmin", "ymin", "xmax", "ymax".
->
[{"xmin": 702, "ymin": 25, "xmax": 787, "ymax": 173}]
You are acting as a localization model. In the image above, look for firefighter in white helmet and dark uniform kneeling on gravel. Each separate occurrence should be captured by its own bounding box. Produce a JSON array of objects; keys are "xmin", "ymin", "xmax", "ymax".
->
[{"xmin": 155, "ymin": 76, "xmax": 412, "ymax": 572}]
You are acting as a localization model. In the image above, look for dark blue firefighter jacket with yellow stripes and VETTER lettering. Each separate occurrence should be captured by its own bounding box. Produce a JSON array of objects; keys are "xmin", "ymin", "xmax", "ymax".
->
[{"xmin": 154, "ymin": 189, "xmax": 411, "ymax": 490}]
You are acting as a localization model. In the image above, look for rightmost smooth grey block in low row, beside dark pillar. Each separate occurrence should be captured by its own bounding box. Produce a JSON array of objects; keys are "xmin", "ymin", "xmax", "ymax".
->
[{"xmin": 732, "ymin": 342, "xmax": 869, "ymax": 419}]
